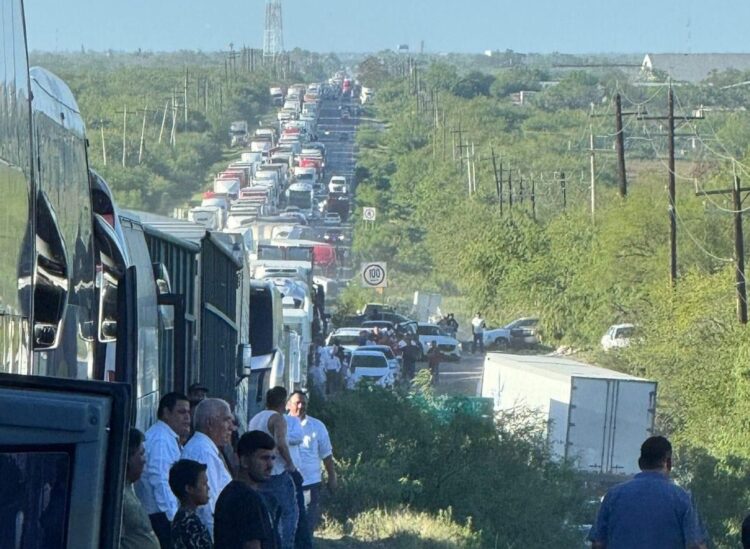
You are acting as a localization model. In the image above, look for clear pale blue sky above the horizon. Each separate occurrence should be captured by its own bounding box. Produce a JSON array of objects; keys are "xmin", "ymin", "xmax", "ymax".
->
[{"xmin": 25, "ymin": 0, "xmax": 750, "ymax": 53}]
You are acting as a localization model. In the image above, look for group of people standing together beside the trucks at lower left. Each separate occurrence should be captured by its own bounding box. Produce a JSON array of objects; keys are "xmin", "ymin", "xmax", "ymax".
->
[{"xmin": 120, "ymin": 384, "xmax": 336, "ymax": 549}]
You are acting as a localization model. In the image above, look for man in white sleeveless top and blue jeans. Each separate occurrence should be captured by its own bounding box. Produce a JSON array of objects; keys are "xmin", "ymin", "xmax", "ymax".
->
[{"xmin": 247, "ymin": 387, "xmax": 299, "ymax": 549}]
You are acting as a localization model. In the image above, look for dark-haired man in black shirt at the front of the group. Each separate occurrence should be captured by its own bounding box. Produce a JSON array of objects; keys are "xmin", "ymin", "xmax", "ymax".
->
[{"xmin": 214, "ymin": 431, "xmax": 278, "ymax": 549}]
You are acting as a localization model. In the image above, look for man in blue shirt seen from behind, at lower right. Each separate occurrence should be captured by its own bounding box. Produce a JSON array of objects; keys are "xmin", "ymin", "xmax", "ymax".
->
[{"xmin": 588, "ymin": 437, "xmax": 707, "ymax": 549}]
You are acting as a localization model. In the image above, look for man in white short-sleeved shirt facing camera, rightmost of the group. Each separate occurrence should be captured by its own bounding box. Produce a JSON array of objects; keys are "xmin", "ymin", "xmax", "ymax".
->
[{"xmin": 287, "ymin": 391, "xmax": 337, "ymax": 537}]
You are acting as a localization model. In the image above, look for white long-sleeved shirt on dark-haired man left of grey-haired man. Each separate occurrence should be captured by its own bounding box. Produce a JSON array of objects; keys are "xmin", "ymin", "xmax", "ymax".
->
[{"xmin": 135, "ymin": 420, "xmax": 180, "ymax": 522}]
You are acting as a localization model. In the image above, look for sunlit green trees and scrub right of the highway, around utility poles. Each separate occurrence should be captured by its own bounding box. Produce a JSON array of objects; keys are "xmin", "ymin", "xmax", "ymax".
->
[{"xmin": 352, "ymin": 55, "xmax": 750, "ymax": 547}]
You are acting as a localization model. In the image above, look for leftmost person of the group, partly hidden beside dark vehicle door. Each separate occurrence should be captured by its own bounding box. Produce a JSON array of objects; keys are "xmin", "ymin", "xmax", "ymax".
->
[{"xmin": 120, "ymin": 429, "xmax": 160, "ymax": 549}]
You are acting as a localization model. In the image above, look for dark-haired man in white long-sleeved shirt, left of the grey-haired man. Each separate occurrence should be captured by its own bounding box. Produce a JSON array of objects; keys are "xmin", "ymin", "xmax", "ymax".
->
[{"xmin": 135, "ymin": 393, "xmax": 190, "ymax": 549}]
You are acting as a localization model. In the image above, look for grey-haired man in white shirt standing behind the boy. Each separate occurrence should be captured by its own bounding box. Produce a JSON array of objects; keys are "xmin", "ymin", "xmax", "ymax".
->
[{"xmin": 181, "ymin": 398, "xmax": 236, "ymax": 538}]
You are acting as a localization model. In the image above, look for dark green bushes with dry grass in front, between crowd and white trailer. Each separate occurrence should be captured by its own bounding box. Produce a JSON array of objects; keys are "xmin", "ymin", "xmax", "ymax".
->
[{"xmin": 310, "ymin": 382, "xmax": 590, "ymax": 549}]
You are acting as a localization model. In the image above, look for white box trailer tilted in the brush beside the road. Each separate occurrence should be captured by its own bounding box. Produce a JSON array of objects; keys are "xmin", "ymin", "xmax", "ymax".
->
[{"xmin": 481, "ymin": 353, "xmax": 656, "ymax": 475}]
